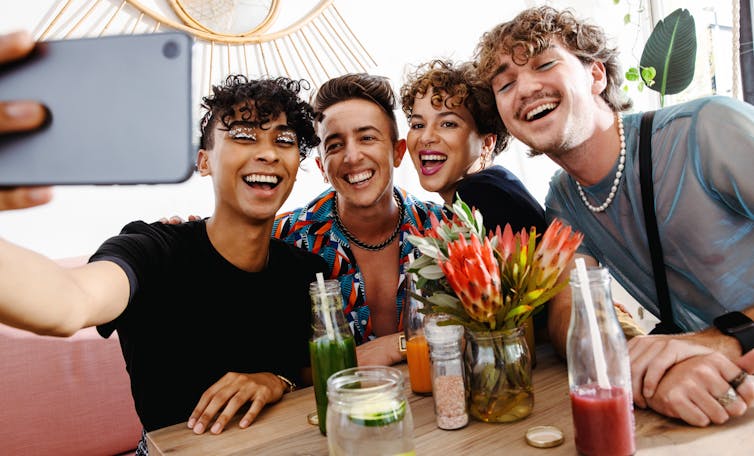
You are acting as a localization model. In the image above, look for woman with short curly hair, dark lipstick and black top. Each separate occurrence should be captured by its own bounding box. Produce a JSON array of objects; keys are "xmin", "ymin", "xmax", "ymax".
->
[{"xmin": 401, "ymin": 60, "xmax": 546, "ymax": 233}]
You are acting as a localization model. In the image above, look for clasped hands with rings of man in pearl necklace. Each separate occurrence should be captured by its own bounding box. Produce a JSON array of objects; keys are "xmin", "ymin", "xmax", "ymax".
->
[{"xmin": 645, "ymin": 352, "xmax": 754, "ymax": 426}]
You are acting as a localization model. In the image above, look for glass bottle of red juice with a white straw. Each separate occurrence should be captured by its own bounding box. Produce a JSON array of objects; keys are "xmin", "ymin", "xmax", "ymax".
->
[{"xmin": 566, "ymin": 268, "xmax": 636, "ymax": 456}]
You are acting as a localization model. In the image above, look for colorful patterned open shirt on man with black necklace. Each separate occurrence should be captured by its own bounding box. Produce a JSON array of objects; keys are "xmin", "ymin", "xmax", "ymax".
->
[{"xmin": 272, "ymin": 189, "xmax": 442, "ymax": 344}]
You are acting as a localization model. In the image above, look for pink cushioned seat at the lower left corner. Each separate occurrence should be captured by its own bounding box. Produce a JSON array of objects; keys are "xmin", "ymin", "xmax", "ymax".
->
[{"xmin": 0, "ymin": 325, "xmax": 141, "ymax": 455}]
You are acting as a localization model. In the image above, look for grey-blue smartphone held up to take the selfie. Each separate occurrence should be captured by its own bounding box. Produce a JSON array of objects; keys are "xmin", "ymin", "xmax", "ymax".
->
[{"xmin": 0, "ymin": 32, "xmax": 196, "ymax": 186}]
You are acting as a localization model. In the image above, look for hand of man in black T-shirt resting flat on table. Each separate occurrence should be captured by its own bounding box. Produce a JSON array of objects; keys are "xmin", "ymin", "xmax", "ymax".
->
[{"xmin": 188, "ymin": 372, "xmax": 286, "ymax": 434}]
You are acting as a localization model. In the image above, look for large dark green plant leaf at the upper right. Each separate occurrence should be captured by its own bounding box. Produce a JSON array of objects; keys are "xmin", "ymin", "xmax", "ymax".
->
[{"xmin": 640, "ymin": 8, "xmax": 696, "ymax": 97}]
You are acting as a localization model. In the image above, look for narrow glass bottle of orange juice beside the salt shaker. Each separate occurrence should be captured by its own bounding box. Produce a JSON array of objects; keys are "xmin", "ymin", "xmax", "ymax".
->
[{"xmin": 403, "ymin": 273, "xmax": 432, "ymax": 396}]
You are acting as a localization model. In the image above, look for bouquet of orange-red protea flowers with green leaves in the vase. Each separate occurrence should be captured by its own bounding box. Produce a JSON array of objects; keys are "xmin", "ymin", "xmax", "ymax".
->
[{"xmin": 409, "ymin": 198, "xmax": 583, "ymax": 330}]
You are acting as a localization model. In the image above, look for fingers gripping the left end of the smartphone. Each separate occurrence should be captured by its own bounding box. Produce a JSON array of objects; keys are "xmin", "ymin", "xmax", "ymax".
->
[{"xmin": 0, "ymin": 31, "xmax": 52, "ymax": 211}]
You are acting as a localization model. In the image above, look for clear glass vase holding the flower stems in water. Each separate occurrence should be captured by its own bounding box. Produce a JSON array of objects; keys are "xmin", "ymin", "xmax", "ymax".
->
[{"xmin": 464, "ymin": 327, "xmax": 534, "ymax": 423}]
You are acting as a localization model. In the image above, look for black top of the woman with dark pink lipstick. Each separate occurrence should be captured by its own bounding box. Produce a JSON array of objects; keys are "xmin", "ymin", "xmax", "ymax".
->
[{"xmin": 453, "ymin": 165, "xmax": 547, "ymax": 236}]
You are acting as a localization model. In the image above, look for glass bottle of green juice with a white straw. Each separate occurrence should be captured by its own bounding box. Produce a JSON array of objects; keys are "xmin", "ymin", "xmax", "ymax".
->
[{"xmin": 309, "ymin": 280, "xmax": 356, "ymax": 435}]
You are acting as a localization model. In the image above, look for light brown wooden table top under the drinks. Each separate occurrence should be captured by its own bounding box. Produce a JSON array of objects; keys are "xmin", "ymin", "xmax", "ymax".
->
[{"xmin": 147, "ymin": 346, "xmax": 754, "ymax": 456}]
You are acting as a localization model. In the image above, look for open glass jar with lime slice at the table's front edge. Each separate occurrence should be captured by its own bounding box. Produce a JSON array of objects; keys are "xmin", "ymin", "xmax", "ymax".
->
[{"xmin": 327, "ymin": 366, "xmax": 415, "ymax": 456}]
